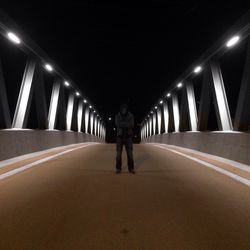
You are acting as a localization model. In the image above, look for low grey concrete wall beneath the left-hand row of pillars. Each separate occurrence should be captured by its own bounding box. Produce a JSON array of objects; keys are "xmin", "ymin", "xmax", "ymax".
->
[{"xmin": 0, "ymin": 129, "xmax": 103, "ymax": 160}]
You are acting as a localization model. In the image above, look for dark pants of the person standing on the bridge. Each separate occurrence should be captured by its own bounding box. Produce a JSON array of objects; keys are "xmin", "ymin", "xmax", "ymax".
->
[{"xmin": 116, "ymin": 137, "xmax": 134, "ymax": 170}]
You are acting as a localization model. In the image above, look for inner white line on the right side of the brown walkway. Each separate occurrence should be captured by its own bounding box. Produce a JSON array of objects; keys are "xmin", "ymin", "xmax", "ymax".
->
[{"xmin": 154, "ymin": 145, "xmax": 250, "ymax": 186}]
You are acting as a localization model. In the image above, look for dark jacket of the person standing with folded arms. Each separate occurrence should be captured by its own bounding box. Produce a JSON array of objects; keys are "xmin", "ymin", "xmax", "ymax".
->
[{"xmin": 115, "ymin": 112, "xmax": 134, "ymax": 137}]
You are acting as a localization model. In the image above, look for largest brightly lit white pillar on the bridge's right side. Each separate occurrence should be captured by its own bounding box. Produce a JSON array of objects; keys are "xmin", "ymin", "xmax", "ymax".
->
[{"xmin": 210, "ymin": 62, "xmax": 233, "ymax": 131}]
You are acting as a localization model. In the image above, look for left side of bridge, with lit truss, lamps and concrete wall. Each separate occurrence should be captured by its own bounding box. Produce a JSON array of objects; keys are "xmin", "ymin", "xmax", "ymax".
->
[{"xmin": 0, "ymin": 12, "xmax": 106, "ymax": 160}]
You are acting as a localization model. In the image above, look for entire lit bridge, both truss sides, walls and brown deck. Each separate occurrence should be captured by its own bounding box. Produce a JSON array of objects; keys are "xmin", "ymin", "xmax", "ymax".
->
[{"xmin": 0, "ymin": 8, "xmax": 250, "ymax": 250}]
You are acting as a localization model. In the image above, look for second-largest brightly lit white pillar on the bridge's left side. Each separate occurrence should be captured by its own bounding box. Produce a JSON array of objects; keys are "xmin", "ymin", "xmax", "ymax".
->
[{"xmin": 48, "ymin": 81, "xmax": 61, "ymax": 129}]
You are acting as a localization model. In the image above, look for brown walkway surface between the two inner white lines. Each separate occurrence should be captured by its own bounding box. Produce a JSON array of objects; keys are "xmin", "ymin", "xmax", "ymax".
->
[{"xmin": 0, "ymin": 144, "xmax": 250, "ymax": 250}]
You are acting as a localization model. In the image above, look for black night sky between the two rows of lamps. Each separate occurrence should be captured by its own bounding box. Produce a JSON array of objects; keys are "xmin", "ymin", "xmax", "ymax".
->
[{"xmin": 0, "ymin": 0, "xmax": 250, "ymax": 139}]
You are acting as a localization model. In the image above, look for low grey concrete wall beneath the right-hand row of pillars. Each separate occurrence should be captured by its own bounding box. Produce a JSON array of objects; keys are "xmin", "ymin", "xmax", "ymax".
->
[{"xmin": 142, "ymin": 132, "xmax": 250, "ymax": 165}]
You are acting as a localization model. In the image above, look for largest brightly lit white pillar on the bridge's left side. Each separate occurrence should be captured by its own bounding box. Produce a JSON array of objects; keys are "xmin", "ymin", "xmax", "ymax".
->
[{"xmin": 12, "ymin": 58, "xmax": 36, "ymax": 128}]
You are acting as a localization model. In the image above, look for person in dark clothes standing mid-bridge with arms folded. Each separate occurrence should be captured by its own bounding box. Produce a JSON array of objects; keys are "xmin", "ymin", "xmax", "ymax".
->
[{"xmin": 115, "ymin": 104, "xmax": 135, "ymax": 174}]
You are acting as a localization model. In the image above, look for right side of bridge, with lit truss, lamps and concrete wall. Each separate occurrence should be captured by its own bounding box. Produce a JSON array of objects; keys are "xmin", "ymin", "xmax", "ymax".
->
[{"xmin": 141, "ymin": 10, "xmax": 250, "ymax": 164}]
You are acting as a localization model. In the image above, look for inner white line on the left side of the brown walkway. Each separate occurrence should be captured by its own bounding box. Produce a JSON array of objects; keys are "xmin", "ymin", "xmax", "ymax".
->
[{"xmin": 0, "ymin": 143, "xmax": 95, "ymax": 180}]
